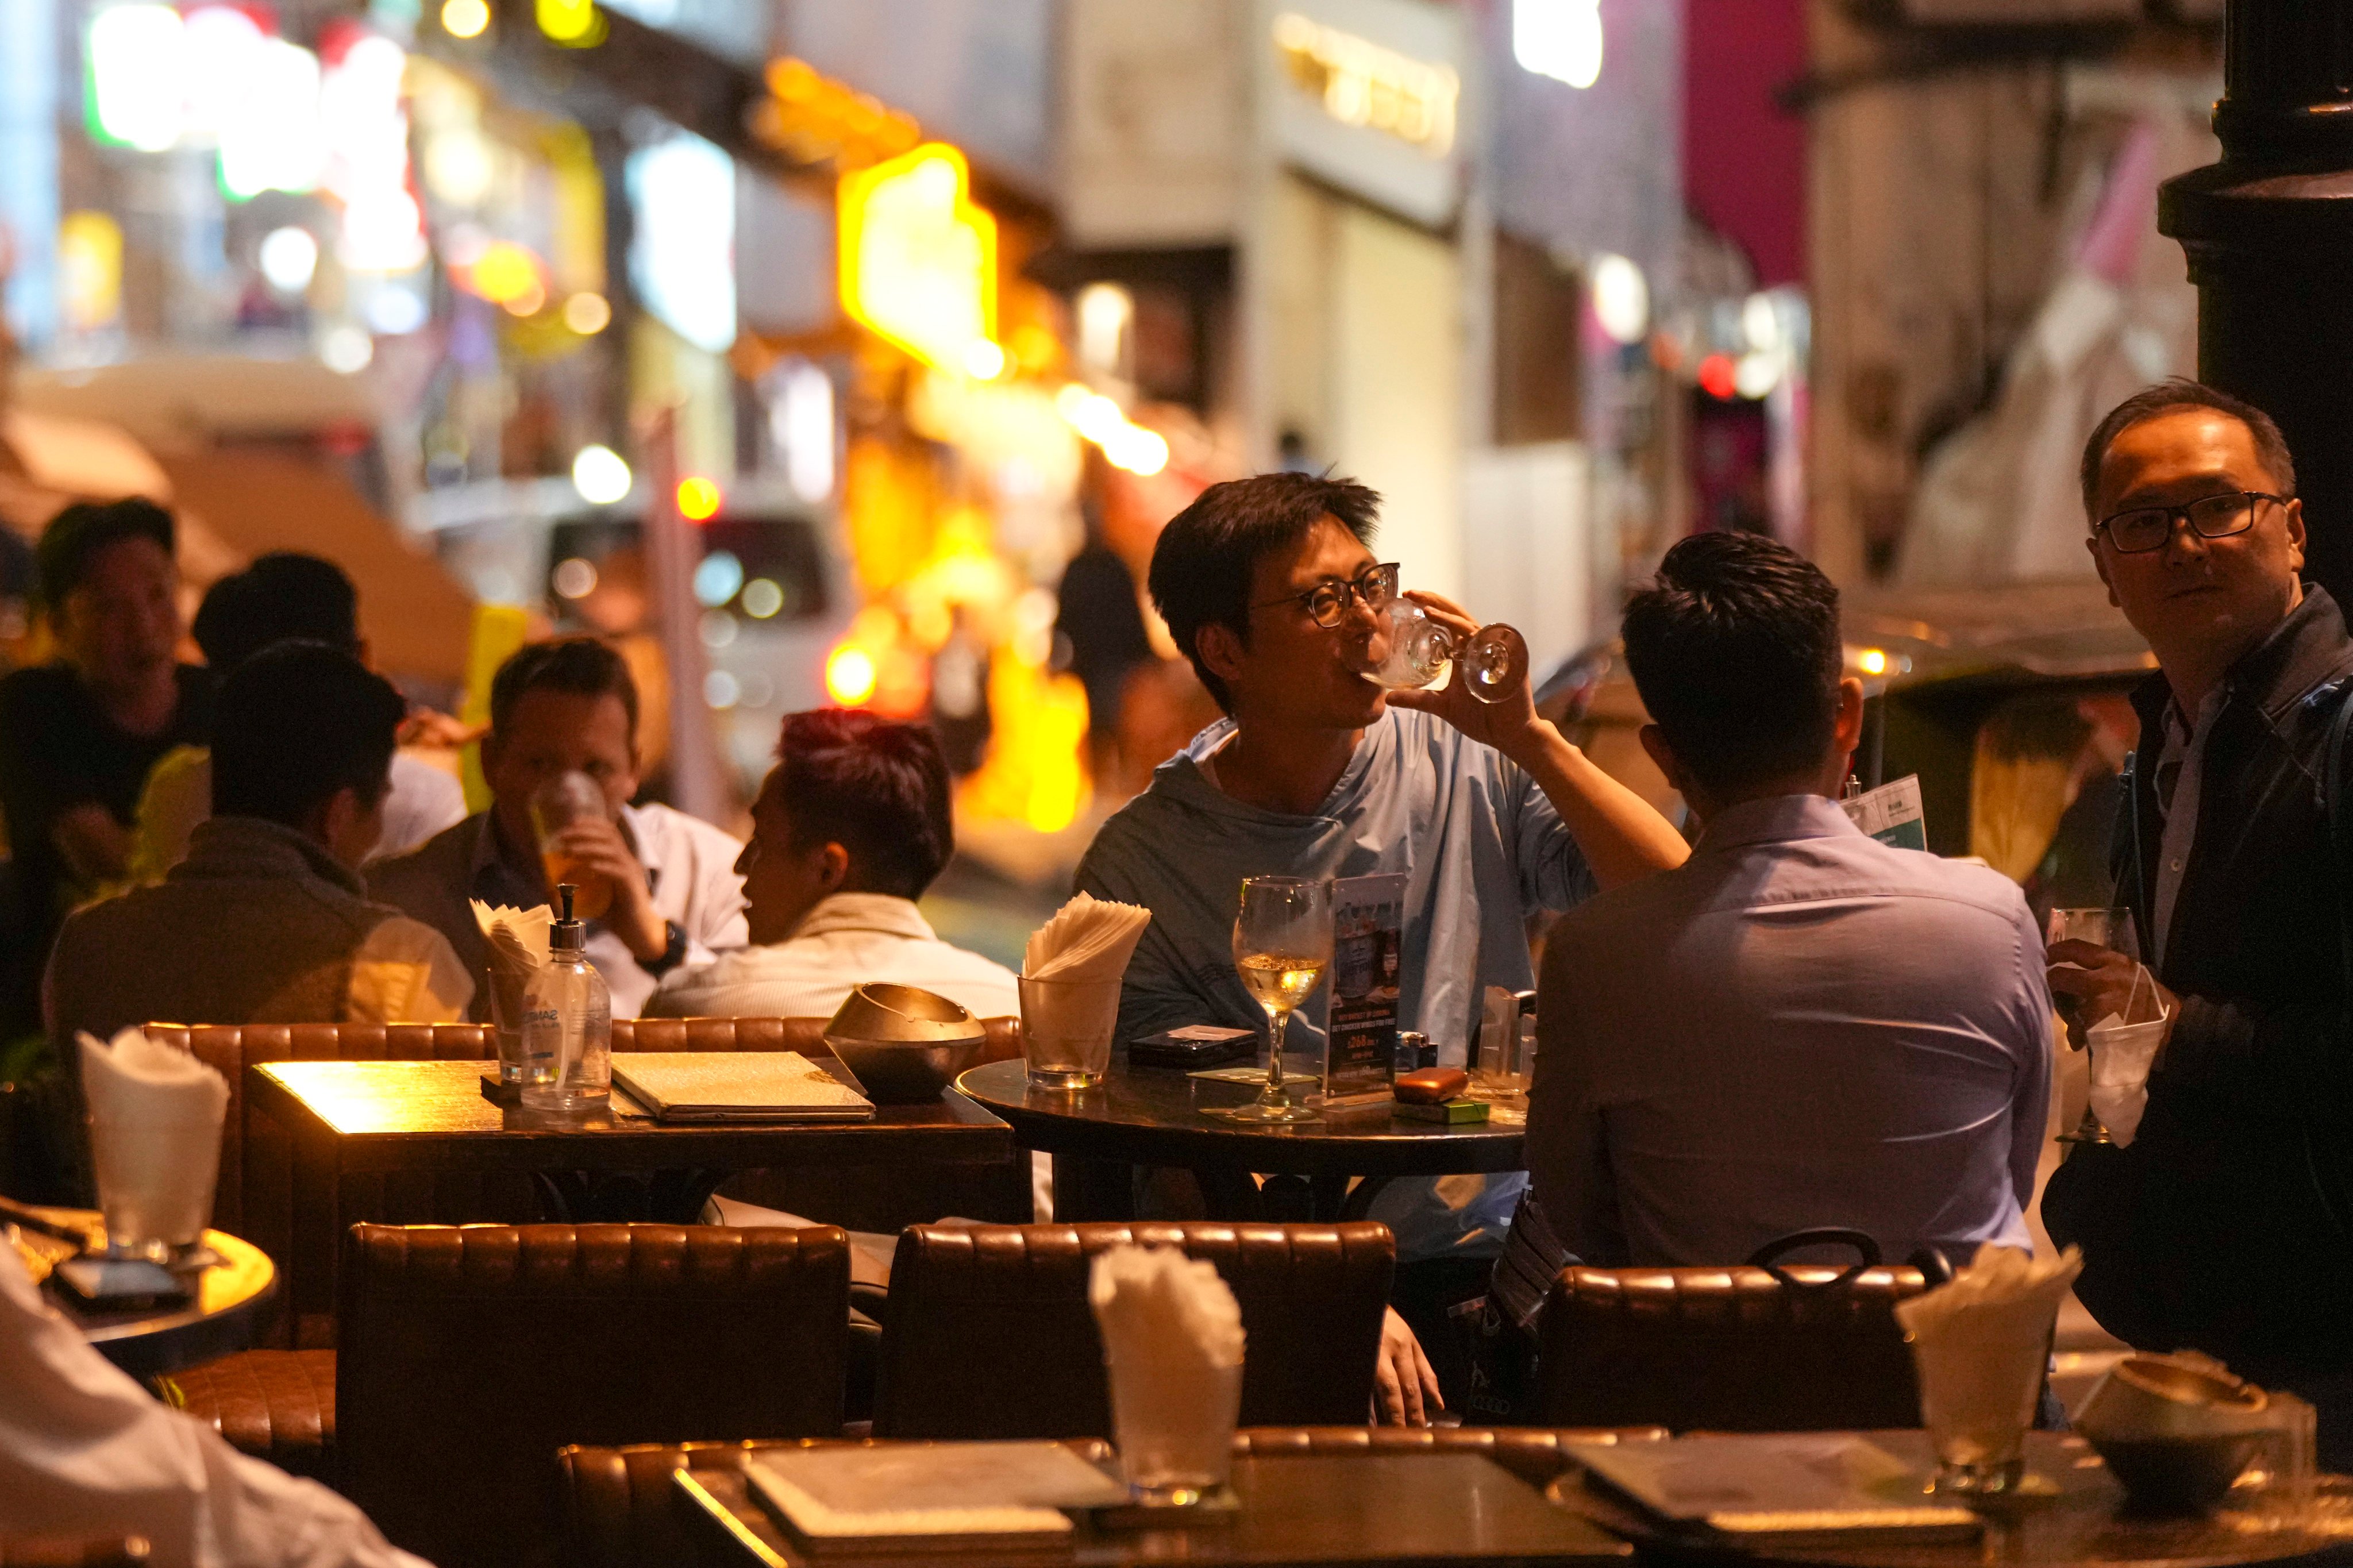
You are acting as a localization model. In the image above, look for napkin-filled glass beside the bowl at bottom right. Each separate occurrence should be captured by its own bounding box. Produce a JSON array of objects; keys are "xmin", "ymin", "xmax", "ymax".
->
[{"xmin": 1897, "ymin": 1240, "xmax": 2082, "ymax": 1462}]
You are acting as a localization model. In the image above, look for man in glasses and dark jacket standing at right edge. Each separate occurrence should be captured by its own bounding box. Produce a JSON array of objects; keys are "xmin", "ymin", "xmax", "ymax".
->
[{"xmin": 2042, "ymin": 382, "xmax": 2353, "ymax": 1467}]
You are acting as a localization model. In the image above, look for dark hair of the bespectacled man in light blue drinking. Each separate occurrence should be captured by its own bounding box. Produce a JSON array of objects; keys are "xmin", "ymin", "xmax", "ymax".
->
[{"xmin": 1148, "ymin": 473, "xmax": 1381, "ymax": 711}]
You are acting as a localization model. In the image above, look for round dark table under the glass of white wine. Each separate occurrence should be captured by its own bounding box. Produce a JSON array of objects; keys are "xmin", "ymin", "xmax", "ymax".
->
[{"xmin": 956, "ymin": 1062, "xmax": 1522, "ymax": 1222}]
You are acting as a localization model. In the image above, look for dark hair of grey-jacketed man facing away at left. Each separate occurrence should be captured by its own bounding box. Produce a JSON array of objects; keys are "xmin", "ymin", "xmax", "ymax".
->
[{"xmin": 212, "ymin": 643, "xmax": 410, "ymax": 826}]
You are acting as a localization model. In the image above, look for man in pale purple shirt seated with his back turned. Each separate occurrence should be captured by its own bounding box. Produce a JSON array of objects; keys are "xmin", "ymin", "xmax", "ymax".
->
[{"xmin": 1494, "ymin": 534, "xmax": 2052, "ymax": 1328}]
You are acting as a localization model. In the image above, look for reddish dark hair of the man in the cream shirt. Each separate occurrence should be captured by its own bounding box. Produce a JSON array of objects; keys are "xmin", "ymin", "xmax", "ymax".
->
[{"xmin": 776, "ymin": 708, "xmax": 956, "ymax": 899}]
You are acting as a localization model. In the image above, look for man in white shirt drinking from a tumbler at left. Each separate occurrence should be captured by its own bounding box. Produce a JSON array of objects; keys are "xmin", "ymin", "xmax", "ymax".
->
[{"xmin": 367, "ymin": 638, "xmax": 746, "ymax": 1017}]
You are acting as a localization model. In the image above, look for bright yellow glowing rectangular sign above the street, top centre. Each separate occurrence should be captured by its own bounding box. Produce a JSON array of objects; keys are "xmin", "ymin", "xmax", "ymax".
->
[{"xmin": 840, "ymin": 141, "xmax": 1002, "ymax": 375}]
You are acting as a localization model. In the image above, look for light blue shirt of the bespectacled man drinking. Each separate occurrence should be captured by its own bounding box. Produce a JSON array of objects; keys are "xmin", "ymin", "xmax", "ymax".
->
[{"xmin": 1078, "ymin": 708, "xmax": 1593, "ymax": 1262}]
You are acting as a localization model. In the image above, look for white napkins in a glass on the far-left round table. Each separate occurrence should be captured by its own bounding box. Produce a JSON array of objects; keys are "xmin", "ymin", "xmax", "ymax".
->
[{"xmin": 80, "ymin": 1029, "xmax": 228, "ymax": 1246}]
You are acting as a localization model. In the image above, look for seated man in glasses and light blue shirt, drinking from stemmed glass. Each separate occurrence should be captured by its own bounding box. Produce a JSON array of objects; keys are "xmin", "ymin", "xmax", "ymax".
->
[{"xmin": 1078, "ymin": 473, "xmax": 1687, "ymax": 1424}]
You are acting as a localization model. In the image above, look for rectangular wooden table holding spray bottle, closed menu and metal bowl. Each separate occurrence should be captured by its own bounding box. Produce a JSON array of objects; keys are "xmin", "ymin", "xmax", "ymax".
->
[{"xmin": 245, "ymin": 1062, "xmax": 1014, "ymax": 1319}]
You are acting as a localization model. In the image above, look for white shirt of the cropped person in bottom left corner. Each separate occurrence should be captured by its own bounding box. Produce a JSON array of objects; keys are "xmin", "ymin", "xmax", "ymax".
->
[{"xmin": 0, "ymin": 1246, "xmax": 428, "ymax": 1568}]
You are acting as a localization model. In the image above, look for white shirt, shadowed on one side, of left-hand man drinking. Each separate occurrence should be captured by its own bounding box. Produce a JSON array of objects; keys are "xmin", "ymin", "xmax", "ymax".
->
[{"xmin": 367, "ymin": 803, "xmax": 750, "ymax": 1017}]
